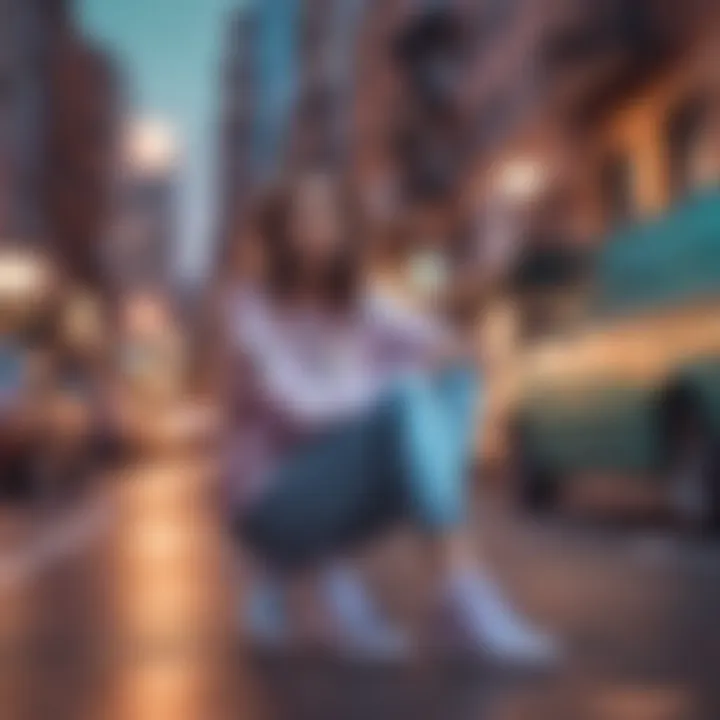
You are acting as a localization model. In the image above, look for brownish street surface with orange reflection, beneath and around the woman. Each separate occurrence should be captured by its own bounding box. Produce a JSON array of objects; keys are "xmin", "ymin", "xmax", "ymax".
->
[{"xmin": 0, "ymin": 448, "xmax": 720, "ymax": 720}]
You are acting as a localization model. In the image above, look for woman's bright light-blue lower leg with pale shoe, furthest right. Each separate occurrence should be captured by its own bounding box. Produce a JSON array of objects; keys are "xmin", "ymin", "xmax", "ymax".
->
[{"xmin": 390, "ymin": 368, "xmax": 553, "ymax": 661}]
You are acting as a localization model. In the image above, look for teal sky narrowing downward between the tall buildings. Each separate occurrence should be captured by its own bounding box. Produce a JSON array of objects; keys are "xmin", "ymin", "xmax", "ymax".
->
[{"xmin": 80, "ymin": 0, "xmax": 242, "ymax": 282}]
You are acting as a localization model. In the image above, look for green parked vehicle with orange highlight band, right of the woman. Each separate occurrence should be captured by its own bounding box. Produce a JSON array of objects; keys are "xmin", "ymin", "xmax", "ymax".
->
[{"xmin": 511, "ymin": 190, "xmax": 720, "ymax": 529}]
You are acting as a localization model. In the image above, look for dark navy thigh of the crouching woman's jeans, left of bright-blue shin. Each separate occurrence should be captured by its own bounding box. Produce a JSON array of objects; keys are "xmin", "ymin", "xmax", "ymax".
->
[{"xmin": 237, "ymin": 416, "xmax": 402, "ymax": 574}]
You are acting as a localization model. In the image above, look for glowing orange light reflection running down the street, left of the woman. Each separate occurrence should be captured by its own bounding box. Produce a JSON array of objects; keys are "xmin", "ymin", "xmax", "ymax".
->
[{"xmin": 101, "ymin": 462, "xmax": 239, "ymax": 720}]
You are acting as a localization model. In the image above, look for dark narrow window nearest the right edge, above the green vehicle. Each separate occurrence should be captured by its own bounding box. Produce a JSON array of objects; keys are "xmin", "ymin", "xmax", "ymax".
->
[{"xmin": 666, "ymin": 98, "xmax": 710, "ymax": 200}]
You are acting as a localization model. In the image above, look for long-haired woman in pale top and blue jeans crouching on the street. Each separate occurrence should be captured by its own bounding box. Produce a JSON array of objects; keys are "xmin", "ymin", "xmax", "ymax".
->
[{"xmin": 225, "ymin": 175, "xmax": 552, "ymax": 660}]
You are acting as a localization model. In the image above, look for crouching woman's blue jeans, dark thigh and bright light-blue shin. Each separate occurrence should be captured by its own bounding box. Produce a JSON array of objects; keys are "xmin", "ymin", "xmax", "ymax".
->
[{"xmin": 237, "ymin": 367, "xmax": 477, "ymax": 570}]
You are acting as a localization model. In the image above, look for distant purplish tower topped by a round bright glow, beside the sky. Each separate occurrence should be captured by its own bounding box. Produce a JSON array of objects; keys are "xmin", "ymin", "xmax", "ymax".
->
[{"xmin": 106, "ymin": 118, "xmax": 180, "ymax": 292}]
